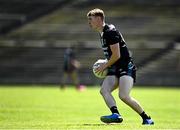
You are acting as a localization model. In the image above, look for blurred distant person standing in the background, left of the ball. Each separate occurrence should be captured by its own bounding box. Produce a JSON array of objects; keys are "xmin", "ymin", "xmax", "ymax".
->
[{"xmin": 60, "ymin": 47, "xmax": 85, "ymax": 91}]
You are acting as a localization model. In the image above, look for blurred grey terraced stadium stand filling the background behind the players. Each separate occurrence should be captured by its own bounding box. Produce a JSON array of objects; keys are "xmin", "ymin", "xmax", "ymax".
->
[{"xmin": 0, "ymin": 0, "xmax": 180, "ymax": 86}]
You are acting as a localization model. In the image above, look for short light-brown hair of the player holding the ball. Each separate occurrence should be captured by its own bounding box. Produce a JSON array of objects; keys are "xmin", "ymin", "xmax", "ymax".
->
[{"xmin": 87, "ymin": 8, "xmax": 105, "ymax": 20}]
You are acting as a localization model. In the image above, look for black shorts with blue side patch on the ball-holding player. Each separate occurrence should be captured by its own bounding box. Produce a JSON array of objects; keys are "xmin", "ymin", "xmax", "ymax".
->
[{"xmin": 107, "ymin": 61, "xmax": 136, "ymax": 82}]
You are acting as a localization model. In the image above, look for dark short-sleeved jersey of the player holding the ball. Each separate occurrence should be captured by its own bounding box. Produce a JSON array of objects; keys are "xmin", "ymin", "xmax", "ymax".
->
[{"xmin": 100, "ymin": 24, "xmax": 131, "ymax": 71}]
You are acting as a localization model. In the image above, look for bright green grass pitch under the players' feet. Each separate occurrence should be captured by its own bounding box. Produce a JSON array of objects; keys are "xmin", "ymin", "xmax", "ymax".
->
[{"xmin": 0, "ymin": 86, "xmax": 180, "ymax": 130}]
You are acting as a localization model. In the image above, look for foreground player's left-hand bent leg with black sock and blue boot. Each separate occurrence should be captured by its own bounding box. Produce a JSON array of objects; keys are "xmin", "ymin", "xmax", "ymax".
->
[{"xmin": 100, "ymin": 76, "xmax": 123, "ymax": 123}]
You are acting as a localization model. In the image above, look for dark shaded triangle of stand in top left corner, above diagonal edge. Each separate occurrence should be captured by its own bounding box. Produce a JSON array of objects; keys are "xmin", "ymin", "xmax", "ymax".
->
[{"xmin": 0, "ymin": 0, "xmax": 74, "ymax": 35}]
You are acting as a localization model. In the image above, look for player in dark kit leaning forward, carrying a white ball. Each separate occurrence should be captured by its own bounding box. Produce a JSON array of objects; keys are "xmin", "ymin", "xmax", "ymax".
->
[{"xmin": 87, "ymin": 9, "xmax": 154, "ymax": 125}]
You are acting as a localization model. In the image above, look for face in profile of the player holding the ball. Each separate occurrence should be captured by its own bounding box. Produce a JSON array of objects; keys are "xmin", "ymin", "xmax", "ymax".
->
[{"xmin": 88, "ymin": 16, "xmax": 100, "ymax": 31}]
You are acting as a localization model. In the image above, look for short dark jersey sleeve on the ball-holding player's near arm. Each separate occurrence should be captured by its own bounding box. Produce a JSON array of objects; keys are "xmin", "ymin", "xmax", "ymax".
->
[{"xmin": 105, "ymin": 30, "xmax": 121, "ymax": 45}]
